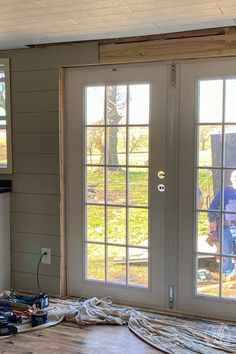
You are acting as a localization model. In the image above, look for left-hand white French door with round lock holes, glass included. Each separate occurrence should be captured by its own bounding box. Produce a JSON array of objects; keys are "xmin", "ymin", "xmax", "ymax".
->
[{"xmin": 65, "ymin": 64, "xmax": 168, "ymax": 307}]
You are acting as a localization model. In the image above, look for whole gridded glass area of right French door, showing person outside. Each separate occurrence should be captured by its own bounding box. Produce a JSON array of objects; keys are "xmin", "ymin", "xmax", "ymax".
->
[{"xmin": 195, "ymin": 78, "xmax": 236, "ymax": 299}]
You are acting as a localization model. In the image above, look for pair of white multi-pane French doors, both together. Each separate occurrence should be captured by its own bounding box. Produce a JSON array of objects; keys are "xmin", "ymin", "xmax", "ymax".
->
[{"xmin": 65, "ymin": 60, "xmax": 236, "ymax": 318}]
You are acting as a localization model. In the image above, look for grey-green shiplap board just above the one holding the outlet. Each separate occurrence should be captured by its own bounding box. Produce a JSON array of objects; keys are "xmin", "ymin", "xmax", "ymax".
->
[{"xmin": 11, "ymin": 212, "xmax": 60, "ymax": 235}]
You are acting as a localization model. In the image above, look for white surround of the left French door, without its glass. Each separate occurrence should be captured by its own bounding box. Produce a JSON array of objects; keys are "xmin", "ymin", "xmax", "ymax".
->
[{"xmin": 64, "ymin": 63, "xmax": 170, "ymax": 307}]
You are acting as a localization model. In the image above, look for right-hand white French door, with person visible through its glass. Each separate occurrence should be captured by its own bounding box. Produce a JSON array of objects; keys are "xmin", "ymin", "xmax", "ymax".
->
[{"xmin": 178, "ymin": 59, "xmax": 236, "ymax": 320}]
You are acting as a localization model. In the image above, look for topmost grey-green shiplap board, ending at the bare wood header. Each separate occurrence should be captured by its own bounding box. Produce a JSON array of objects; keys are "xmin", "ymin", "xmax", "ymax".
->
[{"xmin": 0, "ymin": 41, "xmax": 98, "ymax": 72}]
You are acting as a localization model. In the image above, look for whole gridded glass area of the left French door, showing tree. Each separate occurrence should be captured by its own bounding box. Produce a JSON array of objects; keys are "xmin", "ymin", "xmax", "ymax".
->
[{"xmin": 84, "ymin": 83, "xmax": 150, "ymax": 287}]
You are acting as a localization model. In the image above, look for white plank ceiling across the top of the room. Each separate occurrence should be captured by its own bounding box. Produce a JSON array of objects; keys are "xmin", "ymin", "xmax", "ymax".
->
[{"xmin": 0, "ymin": 0, "xmax": 236, "ymax": 49}]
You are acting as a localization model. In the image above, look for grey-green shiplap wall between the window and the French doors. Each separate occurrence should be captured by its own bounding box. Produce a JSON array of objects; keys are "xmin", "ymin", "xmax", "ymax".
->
[{"xmin": 0, "ymin": 42, "xmax": 98, "ymax": 294}]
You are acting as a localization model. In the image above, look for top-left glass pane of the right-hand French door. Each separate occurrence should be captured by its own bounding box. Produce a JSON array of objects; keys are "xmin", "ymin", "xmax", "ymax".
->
[{"xmin": 198, "ymin": 80, "xmax": 223, "ymax": 123}]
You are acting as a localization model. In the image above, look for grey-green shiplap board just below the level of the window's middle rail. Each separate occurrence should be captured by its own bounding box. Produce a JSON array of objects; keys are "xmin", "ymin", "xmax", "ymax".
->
[{"xmin": 13, "ymin": 133, "xmax": 59, "ymax": 154}]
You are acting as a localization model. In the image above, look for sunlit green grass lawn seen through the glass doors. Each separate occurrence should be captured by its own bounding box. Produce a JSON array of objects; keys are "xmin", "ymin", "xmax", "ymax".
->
[{"xmin": 86, "ymin": 140, "xmax": 218, "ymax": 286}]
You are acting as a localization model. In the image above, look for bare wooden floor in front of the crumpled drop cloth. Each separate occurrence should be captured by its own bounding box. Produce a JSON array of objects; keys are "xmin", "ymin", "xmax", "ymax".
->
[{"xmin": 0, "ymin": 322, "xmax": 162, "ymax": 354}]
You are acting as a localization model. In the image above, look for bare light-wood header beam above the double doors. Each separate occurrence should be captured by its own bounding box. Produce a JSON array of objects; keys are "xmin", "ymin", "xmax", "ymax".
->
[{"xmin": 99, "ymin": 34, "xmax": 236, "ymax": 63}]
